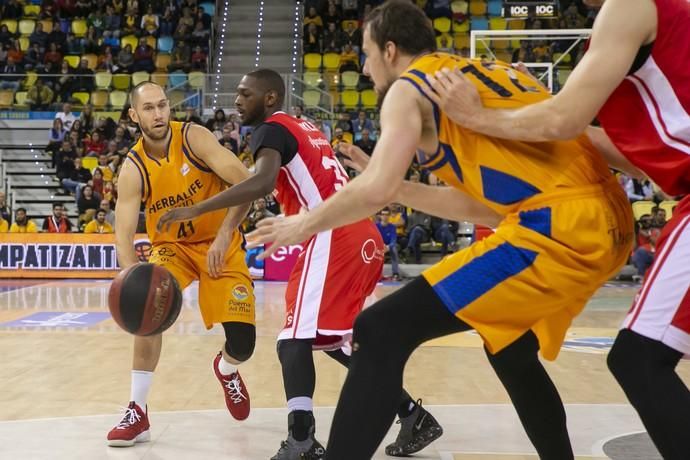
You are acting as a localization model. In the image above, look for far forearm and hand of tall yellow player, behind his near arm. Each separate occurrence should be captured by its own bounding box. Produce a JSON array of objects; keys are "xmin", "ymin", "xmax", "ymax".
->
[{"xmin": 339, "ymin": 144, "xmax": 502, "ymax": 228}]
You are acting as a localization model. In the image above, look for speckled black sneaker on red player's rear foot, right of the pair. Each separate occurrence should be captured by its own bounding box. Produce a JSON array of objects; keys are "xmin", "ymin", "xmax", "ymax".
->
[{"xmin": 386, "ymin": 399, "xmax": 443, "ymax": 457}]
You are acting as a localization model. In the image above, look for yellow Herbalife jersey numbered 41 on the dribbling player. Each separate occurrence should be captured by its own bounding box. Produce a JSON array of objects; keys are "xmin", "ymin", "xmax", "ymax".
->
[{"xmin": 127, "ymin": 121, "xmax": 242, "ymax": 246}]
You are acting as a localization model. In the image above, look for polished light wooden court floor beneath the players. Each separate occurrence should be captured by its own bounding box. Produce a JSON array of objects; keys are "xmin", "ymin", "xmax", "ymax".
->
[{"xmin": 0, "ymin": 280, "xmax": 690, "ymax": 460}]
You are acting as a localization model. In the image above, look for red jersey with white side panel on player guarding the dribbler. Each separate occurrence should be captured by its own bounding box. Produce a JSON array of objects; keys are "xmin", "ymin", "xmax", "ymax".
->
[{"xmin": 265, "ymin": 112, "xmax": 348, "ymax": 216}]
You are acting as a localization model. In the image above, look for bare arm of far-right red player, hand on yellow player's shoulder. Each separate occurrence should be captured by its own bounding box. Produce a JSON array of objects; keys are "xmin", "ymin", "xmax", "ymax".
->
[{"xmin": 428, "ymin": 0, "xmax": 657, "ymax": 142}]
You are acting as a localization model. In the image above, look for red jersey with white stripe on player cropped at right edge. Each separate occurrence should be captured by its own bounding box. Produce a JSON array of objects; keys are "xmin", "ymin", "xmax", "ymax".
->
[{"xmin": 599, "ymin": 0, "xmax": 690, "ymax": 195}]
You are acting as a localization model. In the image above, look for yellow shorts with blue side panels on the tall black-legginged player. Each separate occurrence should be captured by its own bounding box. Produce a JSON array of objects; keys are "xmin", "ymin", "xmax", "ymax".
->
[{"xmin": 422, "ymin": 181, "xmax": 633, "ymax": 360}]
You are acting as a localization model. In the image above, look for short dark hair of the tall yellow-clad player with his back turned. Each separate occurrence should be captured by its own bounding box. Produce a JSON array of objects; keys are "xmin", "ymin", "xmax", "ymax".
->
[{"xmin": 364, "ymin": 0, "xmax": 436, "ymax": 56}]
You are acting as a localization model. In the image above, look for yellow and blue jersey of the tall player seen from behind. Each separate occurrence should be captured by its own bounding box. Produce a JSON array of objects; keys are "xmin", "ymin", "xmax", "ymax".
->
[{"xmin": 400, "ymin": 53, "xmax": 610, "ymax": 214}]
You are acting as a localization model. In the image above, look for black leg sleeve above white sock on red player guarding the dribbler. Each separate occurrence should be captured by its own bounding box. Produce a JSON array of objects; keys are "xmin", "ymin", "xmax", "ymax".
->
[{"xmin": 277, "ymin": 339, "xmax": 316, "ymax": 401}]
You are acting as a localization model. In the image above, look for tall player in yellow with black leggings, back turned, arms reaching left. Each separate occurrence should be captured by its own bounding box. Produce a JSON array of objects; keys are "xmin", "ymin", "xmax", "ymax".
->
[{"xmin": 250, "ymin": 0, "xmax": 632, "ymax": 460}]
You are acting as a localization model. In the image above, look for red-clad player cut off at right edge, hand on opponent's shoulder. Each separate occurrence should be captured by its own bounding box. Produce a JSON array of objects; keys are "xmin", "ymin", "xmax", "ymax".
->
[{"xmin": 427, "ymin": 0, "xmax": 690, "ymax": 454}]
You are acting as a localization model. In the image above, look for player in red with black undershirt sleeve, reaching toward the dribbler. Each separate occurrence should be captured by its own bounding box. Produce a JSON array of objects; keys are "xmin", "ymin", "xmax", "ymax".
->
[{"xmin": 159, "ymin": 69, "xmax": 443, "ymax": 460}]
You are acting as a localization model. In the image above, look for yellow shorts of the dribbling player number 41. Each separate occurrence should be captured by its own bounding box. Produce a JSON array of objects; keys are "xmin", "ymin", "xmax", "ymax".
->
[{"xmin": 149, "ymin": 241, "xmax": 256, "ymax": 329}]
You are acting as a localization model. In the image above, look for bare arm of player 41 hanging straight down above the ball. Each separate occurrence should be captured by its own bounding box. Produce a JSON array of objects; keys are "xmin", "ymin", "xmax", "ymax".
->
[{"xmin": 115, "ymin": 160, "xmax": 143, "ymax": 269}]
